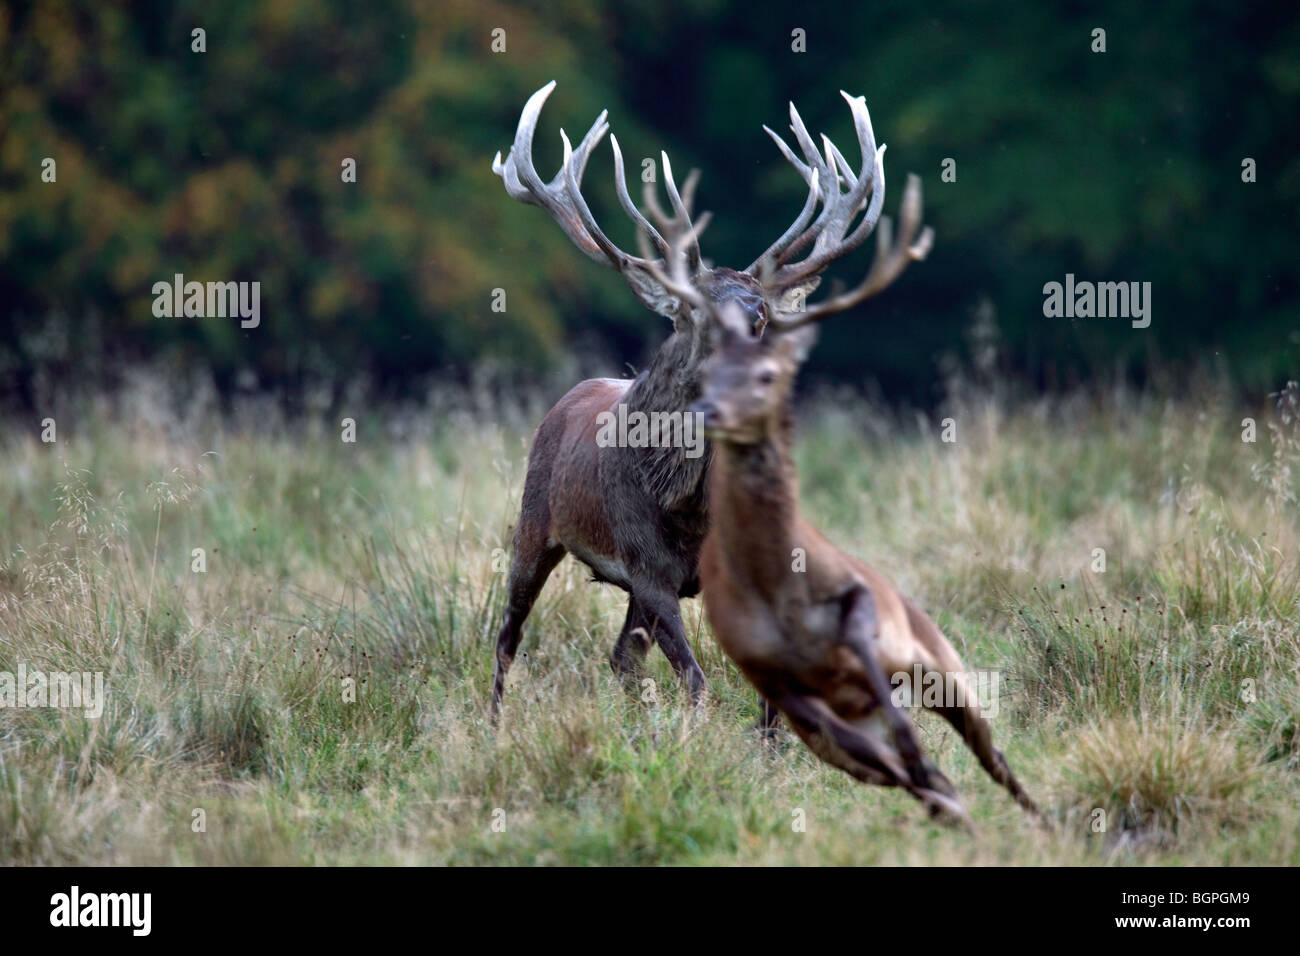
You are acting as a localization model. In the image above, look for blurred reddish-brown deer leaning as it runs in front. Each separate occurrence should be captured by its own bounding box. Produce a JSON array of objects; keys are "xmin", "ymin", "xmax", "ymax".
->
[{"xmin": 653, "ymin": 184, "xmax": 1039, "ymax": 826}]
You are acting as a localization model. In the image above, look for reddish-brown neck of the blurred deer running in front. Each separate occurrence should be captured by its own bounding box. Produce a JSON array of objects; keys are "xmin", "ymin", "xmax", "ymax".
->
[{"xmin": 709, "ymin": 416, "xmax": 809, "ymax": 598}]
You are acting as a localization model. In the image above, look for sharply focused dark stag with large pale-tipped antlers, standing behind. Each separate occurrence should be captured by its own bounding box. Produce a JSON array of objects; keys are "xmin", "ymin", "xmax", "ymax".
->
[{"xmin": 491, "ymin": 81, "xmax": 915, "ymax": 726}]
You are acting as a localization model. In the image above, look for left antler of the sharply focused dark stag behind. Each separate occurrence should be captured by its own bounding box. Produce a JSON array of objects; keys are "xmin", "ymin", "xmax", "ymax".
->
[{"xmin": 491, "ymin": 79, "xmax": 701, "ymax": 316}]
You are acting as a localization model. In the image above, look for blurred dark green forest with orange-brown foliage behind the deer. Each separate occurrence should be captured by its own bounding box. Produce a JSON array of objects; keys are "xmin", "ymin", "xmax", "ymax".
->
[{"xmin": 0, "ymin": 0, "xmax": 1300, "ymax": 406}]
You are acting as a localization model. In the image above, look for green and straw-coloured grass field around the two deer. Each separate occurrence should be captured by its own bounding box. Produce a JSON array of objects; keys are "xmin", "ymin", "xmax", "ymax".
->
[{"xmin": 0, "ymin": 374, "xmax": 1300, "ymax": 865}]
